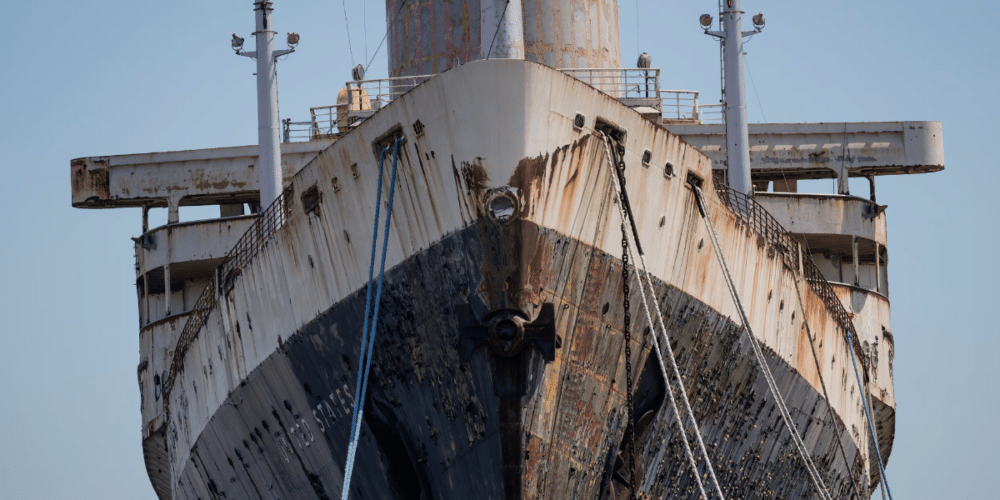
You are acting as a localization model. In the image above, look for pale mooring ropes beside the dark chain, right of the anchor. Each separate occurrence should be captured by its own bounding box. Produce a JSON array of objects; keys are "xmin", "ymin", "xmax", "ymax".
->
[{"xmin": 602, "ymin": 133, "xmax": 726, "ymax": 500}]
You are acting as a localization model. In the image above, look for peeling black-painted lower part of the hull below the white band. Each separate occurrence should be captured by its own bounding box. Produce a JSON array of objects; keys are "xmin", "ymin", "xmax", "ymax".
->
[{"xmin": 175, "ymin": 222, "xmax": 864, "ymax": 499}]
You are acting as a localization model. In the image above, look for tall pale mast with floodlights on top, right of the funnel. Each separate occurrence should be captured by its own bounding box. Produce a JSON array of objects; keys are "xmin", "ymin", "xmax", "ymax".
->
[{"xmin": 699, "ymin": 0, "xmax": 764, "ymax": 196}]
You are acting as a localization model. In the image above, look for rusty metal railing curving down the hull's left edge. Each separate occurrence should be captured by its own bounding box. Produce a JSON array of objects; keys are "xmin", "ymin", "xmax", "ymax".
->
[{"xmin": 163, "ymin": 186, "xmax": 293, "ymax": 400}]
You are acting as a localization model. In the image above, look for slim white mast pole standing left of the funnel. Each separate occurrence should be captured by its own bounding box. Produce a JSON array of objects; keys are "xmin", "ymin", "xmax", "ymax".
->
[{"xmin": 254, "ymin": 0, "xmax": 282, "ymax": 208}]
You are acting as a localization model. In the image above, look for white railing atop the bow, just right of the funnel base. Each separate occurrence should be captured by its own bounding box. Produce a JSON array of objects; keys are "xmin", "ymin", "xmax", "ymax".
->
[{"xmin": 559, "ymin": 68, "xmax": 663, "ymax": 110}]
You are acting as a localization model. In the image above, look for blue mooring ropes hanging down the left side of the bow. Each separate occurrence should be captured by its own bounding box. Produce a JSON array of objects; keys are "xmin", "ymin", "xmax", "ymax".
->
[{"xmin": 340, "ymin": 138, "xmax": 401, "ymax": 500}]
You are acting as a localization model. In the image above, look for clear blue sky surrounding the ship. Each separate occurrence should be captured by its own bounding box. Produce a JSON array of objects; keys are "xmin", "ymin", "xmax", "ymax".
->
[{"xmin": 0, "ymin": 0, "xmax": 1000, "ymax": 500}]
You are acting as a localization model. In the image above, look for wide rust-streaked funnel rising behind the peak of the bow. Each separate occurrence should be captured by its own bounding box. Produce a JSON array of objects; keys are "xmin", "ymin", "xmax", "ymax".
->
[{"xmin": 386, "ymin": 0, "xmax": 621, "ymax": 77}]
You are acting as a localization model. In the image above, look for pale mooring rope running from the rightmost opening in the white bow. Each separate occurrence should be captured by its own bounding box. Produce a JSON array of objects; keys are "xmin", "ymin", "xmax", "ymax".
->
[{"xmin": 692, "ymin": 186, "xmax": 832, "ymax": 500}]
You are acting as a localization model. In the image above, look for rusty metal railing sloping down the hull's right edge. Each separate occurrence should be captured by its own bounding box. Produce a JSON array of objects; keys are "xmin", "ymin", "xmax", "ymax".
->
[{"xmin": 715, "ymin": 183, "xmax": 868, "ymax": 366}]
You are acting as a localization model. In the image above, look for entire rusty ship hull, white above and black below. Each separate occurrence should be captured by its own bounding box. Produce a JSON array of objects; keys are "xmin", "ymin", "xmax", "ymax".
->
[{"xmin": 125, "ymin": 60, "xmax": 894, "ymax": 499}]
